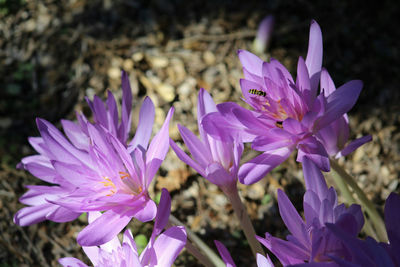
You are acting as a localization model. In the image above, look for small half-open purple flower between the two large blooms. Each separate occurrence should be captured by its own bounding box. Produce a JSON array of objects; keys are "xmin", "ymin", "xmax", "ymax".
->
[{"xmin": 170, "ymin": 88, "xmax": 243, "ymax": 195}]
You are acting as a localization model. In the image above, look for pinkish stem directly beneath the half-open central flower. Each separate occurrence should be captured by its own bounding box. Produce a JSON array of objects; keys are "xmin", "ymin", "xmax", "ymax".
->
[{"xmin": 224, "ymin": 190, "xmax": 265, "ymax": 258}]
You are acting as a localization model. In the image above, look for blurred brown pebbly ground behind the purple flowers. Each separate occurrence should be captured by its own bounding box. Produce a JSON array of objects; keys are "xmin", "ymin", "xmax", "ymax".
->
[{"xmin": 0, "ymin": 0, "xmax": 400, "ymax": 267}]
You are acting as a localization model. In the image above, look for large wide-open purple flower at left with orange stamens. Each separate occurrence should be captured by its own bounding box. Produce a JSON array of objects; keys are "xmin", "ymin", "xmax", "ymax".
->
[{"xmin": 14, "ymin": 71, "xmax": 173, "ymax": 246}]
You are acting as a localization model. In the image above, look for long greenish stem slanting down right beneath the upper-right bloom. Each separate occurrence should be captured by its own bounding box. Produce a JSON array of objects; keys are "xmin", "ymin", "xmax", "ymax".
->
[{"xmin": 331, "ymin": 160, "xmax": 388, "ymax": 243}]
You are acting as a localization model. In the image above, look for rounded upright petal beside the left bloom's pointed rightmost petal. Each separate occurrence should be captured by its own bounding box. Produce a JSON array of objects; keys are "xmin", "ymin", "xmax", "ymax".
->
[{"xmin": 129, "ymin": 97, "xmax": 155, "ymax": 152}]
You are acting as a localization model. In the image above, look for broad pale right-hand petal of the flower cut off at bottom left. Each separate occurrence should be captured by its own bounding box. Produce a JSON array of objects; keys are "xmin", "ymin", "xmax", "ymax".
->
[{"xmin": 153, "ymin": 226, "xmax": 187, "ymax": 266}]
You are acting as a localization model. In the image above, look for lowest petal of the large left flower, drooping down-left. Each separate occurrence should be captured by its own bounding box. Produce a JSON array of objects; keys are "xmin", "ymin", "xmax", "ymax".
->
[{"xmin": 77, "ymin": 208, "xmax": 132, "ymax": 246}]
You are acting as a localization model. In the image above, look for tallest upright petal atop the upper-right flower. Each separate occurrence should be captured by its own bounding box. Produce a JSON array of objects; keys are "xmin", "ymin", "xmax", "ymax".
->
[{"xmin": 306, "ymin": 20, "xmax": 323, "ymax": 93}]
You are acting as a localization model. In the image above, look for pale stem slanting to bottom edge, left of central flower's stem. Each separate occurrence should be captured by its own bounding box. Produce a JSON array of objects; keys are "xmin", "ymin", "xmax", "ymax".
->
[{"xmin": 169, "ymin": 214, "xmax": 225, "ymax": 267}]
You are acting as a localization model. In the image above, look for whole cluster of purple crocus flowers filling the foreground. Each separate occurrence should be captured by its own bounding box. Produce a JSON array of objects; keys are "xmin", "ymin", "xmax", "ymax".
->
[{"xmin": 14, "ymin": 17, "xmax": 400, "ymax": 267}]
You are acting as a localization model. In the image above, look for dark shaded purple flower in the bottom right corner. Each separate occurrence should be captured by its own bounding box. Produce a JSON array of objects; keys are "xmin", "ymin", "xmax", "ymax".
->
[{"xmin": 327, "ymin": 193, "xmax": 400, "ymax": 267}]
